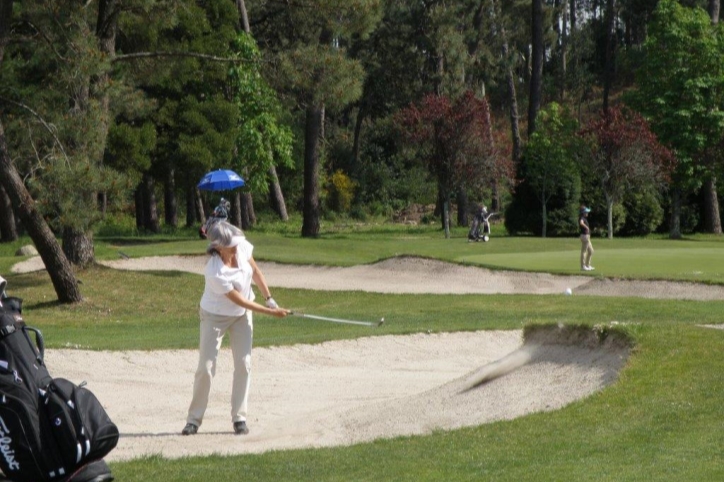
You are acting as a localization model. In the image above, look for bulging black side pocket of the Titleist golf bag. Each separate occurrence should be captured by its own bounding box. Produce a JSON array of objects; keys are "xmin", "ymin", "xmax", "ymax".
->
[{"xmin": 44, "ymin": 378, "xmax": 119, "ymax": 467}]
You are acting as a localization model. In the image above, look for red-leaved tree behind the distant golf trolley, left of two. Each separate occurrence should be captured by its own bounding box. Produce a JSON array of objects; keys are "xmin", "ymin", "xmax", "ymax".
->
[{"xmin": 396, "ymin": 91, "xmax": 514, "ymax": 238}]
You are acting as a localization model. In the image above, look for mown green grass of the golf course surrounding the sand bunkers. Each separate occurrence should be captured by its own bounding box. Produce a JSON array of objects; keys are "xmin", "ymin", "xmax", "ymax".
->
[{"xmin": 0, "ymin": 227, "xmax": 724, "ymax": 482}]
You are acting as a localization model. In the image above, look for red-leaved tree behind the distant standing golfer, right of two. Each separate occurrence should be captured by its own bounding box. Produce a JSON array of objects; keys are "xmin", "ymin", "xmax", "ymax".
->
[{"xmin": 580, "ymin": 107, "xmax": 676, "ymax": 239}]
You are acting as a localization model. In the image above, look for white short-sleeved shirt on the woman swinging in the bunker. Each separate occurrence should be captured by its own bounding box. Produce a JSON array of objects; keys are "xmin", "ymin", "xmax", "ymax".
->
[{"xmin": 201, "ymin": 239, "xmax": 254, "ymax": 316}]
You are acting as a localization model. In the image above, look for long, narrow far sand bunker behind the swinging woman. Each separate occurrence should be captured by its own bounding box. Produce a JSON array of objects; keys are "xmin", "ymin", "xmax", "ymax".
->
[{"xmin": 12, "ymin": 256, "xmax": 724, "ymax": 301}]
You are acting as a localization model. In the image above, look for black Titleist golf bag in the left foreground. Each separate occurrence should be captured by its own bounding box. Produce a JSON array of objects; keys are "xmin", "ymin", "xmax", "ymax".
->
[{"xmin": 0, "ymin": 298, "xmax": 119, "ymax": 482}]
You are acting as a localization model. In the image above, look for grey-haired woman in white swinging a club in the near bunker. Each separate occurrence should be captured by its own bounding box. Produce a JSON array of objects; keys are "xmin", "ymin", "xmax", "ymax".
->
[{"xmin": 181, "ymin": 221, "xmax": 290, "ymax": 435}]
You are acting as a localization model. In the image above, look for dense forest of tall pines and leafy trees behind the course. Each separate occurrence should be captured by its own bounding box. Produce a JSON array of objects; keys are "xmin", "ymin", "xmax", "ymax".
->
[{"xmin": 0, "ymin": 0, "xmax": 724, "ymax": 302}]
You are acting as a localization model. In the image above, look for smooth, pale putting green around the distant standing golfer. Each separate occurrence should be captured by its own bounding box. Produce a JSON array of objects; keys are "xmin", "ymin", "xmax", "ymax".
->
[{"xmin": 458, "ymin": 249, "xmax": 724, "ymax": 283}]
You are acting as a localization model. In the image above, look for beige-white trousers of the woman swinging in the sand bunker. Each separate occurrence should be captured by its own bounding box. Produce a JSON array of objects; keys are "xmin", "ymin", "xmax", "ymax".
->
[{"xmin": 186, "ymin": 310, "xmax": 254, "ymax": 426}]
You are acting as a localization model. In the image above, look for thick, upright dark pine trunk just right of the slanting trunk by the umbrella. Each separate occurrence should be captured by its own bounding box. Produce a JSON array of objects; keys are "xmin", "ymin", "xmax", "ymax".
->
[{"xmin": 302, "ymin": 106, "xmax": 324, "ymax": 238}]
